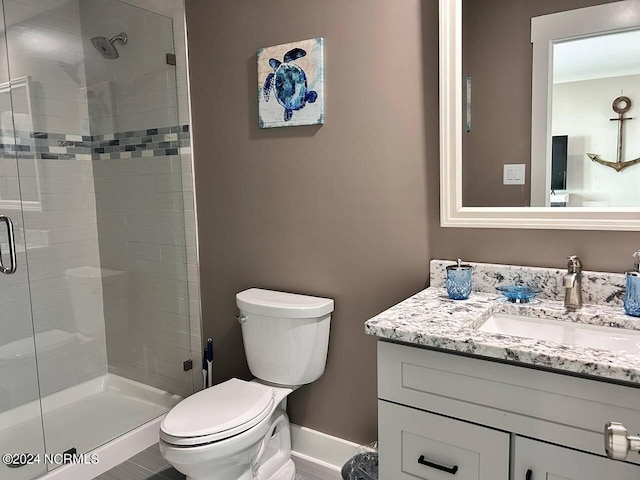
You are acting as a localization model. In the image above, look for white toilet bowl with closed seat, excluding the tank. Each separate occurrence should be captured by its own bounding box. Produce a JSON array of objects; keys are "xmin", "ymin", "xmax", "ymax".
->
[{"xmin": 160, "ymin": 378, "xmax": 293, "ymax": 480}]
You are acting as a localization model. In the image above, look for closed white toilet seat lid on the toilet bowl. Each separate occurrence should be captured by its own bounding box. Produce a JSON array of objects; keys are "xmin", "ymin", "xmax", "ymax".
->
[{"xmin": 160, "ymin": 378, "xmax": 275, "ymax": 446}]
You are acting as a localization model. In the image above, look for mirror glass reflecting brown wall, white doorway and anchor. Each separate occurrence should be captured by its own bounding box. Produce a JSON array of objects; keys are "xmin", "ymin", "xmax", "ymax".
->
[{"xmin": 461, "ymin": 0, "xmax": 640, "ymax": 209}]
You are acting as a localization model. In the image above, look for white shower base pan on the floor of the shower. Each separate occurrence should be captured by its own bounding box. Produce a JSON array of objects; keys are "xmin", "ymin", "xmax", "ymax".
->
[{"xmin": 0, "ymin": 373, "xmax": 182, "ymax": 480}]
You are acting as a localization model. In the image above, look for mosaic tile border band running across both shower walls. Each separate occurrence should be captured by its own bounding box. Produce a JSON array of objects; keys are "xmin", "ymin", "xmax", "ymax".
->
[{"xmin": 0, "ymin": 125, "xmax": 191, "ymax": 160}]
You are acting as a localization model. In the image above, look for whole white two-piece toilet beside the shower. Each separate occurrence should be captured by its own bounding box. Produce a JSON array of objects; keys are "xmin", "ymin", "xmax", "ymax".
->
[{"xmin": 160, "ymin": 288, "xmax": 333, "ymax": 480}]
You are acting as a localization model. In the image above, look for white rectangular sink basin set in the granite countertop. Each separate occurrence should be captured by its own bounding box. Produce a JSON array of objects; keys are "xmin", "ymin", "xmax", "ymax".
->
[{"xmin": 478, "ymin": 313, "xmax": 640, "ymax": 354}]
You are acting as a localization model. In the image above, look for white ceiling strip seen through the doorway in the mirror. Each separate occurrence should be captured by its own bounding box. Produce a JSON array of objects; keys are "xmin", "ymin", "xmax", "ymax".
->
[{"xmin": 553, "ymin": 30, "xmax": 640, "ymax": 83}]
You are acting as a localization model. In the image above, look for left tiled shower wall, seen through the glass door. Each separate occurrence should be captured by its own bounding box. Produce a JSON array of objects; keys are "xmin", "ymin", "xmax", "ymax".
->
[{"xmin": 0, "ymin": 0, "xmax": 106, "ymax": 404}]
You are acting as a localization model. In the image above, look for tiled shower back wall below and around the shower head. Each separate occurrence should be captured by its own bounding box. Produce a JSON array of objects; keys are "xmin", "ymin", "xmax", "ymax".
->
[{"xmin": 81, "ymin": 0, "xmax": 201, "ymax": 395}]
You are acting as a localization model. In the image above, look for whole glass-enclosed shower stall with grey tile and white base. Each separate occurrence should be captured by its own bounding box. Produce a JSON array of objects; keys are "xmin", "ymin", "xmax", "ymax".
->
[{"xmin": 0, "ymin": 0, "xmax": 200, "ymax": 480}]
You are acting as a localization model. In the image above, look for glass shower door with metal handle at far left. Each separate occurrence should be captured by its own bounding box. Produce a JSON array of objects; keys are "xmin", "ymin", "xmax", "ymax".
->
[{"xmin": 0, "ymin": 0, "xmax": 46, "ymax": 480}]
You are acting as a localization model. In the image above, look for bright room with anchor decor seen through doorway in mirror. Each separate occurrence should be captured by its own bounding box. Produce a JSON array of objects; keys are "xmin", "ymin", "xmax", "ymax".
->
[{"xmin": 547, "ymin": 30, "xmax": 640, "ymax": 207}]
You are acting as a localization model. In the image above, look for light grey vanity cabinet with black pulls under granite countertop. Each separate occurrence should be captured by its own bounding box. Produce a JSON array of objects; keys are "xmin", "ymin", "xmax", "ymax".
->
[{"xmin": 378, "ymin": 341, "xmax": 640, "ymax": 480}]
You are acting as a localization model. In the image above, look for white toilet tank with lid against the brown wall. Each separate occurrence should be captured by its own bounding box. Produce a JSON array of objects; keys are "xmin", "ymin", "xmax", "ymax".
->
[{"xmin": 236, "ymin": 288, "xmax": 333, "ymax": 386}]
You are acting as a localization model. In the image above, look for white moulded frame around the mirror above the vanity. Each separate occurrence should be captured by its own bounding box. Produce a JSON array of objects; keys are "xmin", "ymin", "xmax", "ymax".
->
[{"xmin": 439, "ymin": 0, "xmax": 640, "ymax": 231}]
